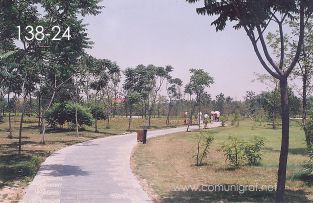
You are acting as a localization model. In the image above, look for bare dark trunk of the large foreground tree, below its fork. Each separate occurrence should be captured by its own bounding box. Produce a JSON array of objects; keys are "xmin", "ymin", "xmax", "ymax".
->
[{"xmin": 276, "ymin": 78, "xmax": 289, "ymax": 202}]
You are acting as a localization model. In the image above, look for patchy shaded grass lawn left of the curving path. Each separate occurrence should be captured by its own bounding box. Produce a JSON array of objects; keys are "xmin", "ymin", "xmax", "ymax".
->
[{"xmin": 0, "ymin": 116, "xmax": 183, "ymax": 202}]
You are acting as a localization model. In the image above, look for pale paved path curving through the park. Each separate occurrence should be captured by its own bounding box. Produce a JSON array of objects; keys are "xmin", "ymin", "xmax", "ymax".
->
[{"xmin": 21, "ymin": 123, "xmax": 220, "ymax": 203}]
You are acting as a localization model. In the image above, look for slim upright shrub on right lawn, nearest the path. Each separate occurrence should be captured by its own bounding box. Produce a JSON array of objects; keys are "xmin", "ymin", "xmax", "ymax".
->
[{"xmin": 195, "ymin": 131, "xmax": 214, "ymax": 166}]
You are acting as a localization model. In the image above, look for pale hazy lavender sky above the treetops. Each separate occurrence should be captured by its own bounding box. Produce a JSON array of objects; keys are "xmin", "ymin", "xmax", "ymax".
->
[{"xmin": 86, "ymin": 0, "xmax": 265, "ymax": 99}]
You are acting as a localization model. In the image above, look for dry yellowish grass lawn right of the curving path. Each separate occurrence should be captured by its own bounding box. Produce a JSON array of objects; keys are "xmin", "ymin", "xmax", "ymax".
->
[{"xmin": 132, "ymin": 121, "xmax": 313, "ymax": 202}]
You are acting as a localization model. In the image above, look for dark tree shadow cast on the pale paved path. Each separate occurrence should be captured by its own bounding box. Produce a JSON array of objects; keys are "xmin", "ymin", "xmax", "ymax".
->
[{"xmin": 39, "ymin": 164, "xmax": 89, "ymax": 177}]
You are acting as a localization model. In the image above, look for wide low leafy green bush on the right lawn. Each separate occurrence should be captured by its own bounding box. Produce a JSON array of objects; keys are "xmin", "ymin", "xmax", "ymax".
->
[{"xmin": 222, "ymin": 137, "xmax": 264, "ymax": 168}]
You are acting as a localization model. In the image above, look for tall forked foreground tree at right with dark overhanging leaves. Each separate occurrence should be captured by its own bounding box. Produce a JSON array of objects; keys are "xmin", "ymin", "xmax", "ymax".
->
[{"xmin": 187, "ymin": 0, "xmax": 313, "ymax": 202}]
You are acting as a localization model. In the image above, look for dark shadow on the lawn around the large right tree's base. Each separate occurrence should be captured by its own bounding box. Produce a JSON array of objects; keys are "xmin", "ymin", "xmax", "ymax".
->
[{"xmin": 161, "ymin": 185, "xmax": 311, "ymax": 203}]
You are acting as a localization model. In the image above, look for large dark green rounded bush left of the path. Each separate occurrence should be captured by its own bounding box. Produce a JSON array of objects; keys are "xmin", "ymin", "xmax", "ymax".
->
[{"xmin": 45, "ymin": 102, "xmax": 93, "ymax": 126}]
